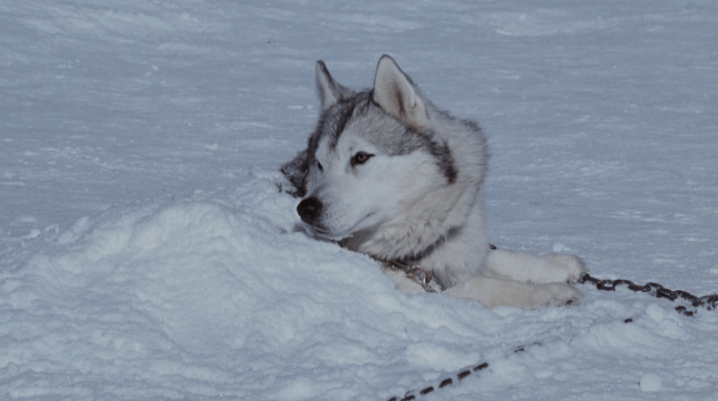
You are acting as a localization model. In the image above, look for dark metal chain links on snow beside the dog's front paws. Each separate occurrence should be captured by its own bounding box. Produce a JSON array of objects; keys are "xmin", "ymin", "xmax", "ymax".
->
[{"xmin": 577, "ymin": 273, "xmax": 718, "ymax": 316}]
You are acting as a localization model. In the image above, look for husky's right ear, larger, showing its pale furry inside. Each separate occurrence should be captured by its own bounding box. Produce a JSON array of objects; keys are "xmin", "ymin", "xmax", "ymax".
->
[{"xmin": 372, "ymin": 54, "xmax": 431, "ymax": 129}]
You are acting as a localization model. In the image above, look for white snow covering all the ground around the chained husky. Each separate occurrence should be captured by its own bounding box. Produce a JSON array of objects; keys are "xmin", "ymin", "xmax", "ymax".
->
[{"xmin": 0, "ymin": 0, "xmax": 718, "ymax": 400}]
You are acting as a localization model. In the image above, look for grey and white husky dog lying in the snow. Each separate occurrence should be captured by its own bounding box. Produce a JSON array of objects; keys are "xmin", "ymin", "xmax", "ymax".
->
[{"xmin": 281, "ymin": 55, "xmax": 587, "ymax": 309}]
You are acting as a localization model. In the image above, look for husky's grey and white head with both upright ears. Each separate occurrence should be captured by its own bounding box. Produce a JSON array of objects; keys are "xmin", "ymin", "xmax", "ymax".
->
[{"xmin": 282, "ymin": 55, "xmax": 472, "ymax": 255}]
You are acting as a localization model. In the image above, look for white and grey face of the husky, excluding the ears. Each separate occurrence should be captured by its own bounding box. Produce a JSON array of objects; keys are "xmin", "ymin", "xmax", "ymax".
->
[{"xmin": 297, "ymin": 105, "xmax": 441, "ymax": 240}]
